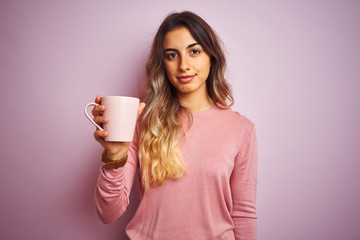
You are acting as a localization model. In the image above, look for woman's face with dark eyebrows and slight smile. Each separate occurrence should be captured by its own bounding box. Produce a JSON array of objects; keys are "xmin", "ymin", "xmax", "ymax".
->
[{"xmin": 163, "ymin": 27, "xmax": 211, "ymax": 97}]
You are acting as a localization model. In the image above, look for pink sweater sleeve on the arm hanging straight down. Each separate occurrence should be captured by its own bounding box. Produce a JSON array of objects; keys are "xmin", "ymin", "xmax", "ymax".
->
[{"xmin": 230, "ymin": 125, "xmax": 257, "ymax": 240}]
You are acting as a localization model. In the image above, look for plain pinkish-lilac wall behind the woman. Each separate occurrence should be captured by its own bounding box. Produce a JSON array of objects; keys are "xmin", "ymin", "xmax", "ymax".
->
[{"xmin": 0, "ymin": 0, "xmax": 360, "ymax": 240}]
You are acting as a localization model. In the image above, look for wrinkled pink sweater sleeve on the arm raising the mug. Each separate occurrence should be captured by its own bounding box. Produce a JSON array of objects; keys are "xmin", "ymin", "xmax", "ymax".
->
[{"xmin": 95, "ymin": 125, "xmax": 138, "ymax": 224}]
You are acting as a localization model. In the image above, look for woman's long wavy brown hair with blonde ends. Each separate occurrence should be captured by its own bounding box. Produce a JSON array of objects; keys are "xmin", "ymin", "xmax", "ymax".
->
[{"xmin": 139, "ymin": 11, "xmax": 234, "ymax": 190}]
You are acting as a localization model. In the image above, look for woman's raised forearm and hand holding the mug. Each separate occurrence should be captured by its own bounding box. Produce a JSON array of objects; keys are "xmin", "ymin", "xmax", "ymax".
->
[{"xmin": 92, "ymin": 95, "xmax": 145, "ymax": 223}]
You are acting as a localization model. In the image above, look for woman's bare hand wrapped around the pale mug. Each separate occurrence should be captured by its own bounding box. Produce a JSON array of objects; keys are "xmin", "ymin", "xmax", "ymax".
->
[{"xmin": 92, "ymin": 95, "xmax": 145, "ymax": 160}]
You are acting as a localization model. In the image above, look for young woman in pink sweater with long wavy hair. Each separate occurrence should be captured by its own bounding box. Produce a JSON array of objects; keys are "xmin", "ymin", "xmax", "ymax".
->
[{"xmin": 93, "ymin": 12, "xmax": 257, "ymax": 240}]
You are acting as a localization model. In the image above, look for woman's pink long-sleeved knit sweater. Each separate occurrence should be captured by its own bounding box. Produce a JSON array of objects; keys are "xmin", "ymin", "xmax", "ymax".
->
[{"xmin": 95, "ymin": 106, "xmax": 257, "ymax": 240}]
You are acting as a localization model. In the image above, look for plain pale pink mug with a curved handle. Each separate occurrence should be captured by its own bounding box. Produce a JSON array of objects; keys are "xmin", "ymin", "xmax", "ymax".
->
[{"xmin": 84, "ymin": 96, "xmax": 139, "ymax": 142}]
